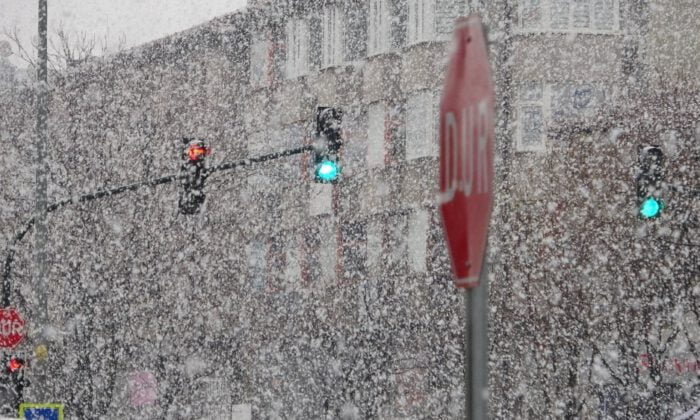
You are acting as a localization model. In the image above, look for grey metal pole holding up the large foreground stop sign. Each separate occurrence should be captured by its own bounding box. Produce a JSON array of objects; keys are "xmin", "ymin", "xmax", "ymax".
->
[{"xmin": 464, "ymin": 248, "xmax": 489, "ymax": 420}]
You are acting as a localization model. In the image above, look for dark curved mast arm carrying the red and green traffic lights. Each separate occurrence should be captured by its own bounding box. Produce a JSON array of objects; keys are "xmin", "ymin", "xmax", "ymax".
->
[{"xmin": 2, "ymin": 145, "xmax": 313, "ymax": 308}]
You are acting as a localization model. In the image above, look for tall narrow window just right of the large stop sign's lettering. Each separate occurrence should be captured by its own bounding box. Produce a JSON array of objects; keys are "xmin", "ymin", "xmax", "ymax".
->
[{"xmin": 518, "ymin": 83, "xmax": 545, "ymax": 151}]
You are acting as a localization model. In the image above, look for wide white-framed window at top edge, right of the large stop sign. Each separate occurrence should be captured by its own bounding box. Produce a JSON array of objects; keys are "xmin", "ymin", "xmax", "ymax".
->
[{"xmin": 519, "ymin": 0, "xmax": 620, "ymax": 33}]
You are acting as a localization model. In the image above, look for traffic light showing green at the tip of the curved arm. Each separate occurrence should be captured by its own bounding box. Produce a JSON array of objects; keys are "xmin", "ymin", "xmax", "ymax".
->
[{"xmin": 314, "ymin": 106, "xmax": 343, "ymax": 183}]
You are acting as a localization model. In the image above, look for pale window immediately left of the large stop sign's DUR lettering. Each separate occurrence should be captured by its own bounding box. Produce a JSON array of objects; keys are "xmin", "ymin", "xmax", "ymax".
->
[{"xmin": 406, "ymin": 90, "xmax": 438, "ymax": 160}]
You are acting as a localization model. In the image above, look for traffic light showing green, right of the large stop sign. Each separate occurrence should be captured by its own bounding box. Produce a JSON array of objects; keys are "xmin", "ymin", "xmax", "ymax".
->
[{"xmin": 636, "ymin": 146, "xmax": 666, "ymax": 219}]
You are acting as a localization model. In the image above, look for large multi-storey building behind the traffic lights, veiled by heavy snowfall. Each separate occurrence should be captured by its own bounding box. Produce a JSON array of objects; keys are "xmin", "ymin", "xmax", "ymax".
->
[{"xmin": 2, "ymin": 0, "xmax": 700, "ymax": 419}]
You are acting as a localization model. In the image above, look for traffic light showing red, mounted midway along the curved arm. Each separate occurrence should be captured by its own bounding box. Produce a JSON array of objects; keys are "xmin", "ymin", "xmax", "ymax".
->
[{"xmin": 178, "ymin": 137, "xmax": 210, "ymax": 214}]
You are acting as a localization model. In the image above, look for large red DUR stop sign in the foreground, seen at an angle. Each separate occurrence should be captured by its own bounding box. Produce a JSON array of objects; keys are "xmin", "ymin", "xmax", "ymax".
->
[{"xmin": 438, "ymin": 15, "xmax": 494, "ymax": 288}]
